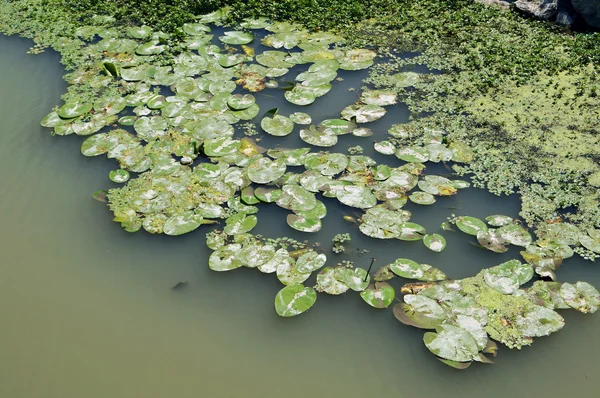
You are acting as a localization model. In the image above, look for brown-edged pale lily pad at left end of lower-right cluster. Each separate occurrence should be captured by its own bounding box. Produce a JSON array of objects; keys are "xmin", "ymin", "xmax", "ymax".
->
[{"xmin": 394, "ymin": 294, "xmax": 447, "ymax": 329}]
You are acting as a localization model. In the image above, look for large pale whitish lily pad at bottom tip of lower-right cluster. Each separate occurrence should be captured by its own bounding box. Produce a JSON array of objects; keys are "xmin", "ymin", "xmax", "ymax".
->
[{"xmin": 423, "ymin": 324, "xmax": 479, "ymax": 362}]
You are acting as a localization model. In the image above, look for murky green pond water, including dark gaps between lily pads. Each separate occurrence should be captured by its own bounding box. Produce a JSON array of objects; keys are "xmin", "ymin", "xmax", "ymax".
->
[{"xmin": 0, "ymin": 36, "xmax": 600, "ymax": 398}]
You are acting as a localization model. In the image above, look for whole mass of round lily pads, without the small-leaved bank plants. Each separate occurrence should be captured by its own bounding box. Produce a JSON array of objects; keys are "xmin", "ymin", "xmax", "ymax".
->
[{"xmin": 31, "ymin": 11, "xmax": 600, "ymax": 368}]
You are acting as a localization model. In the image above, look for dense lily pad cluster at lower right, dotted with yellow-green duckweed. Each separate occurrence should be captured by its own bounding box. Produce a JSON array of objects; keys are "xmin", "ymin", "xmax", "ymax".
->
[{"xmin": 394, "ymin": 260, "xmax": 600, "ymax": 369}]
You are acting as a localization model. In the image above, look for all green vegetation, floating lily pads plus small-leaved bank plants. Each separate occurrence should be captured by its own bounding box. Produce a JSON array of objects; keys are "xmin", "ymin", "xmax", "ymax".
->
[{"xmin": 0, "ymin": 0, "xmax": 600, "ymax": 368}]
